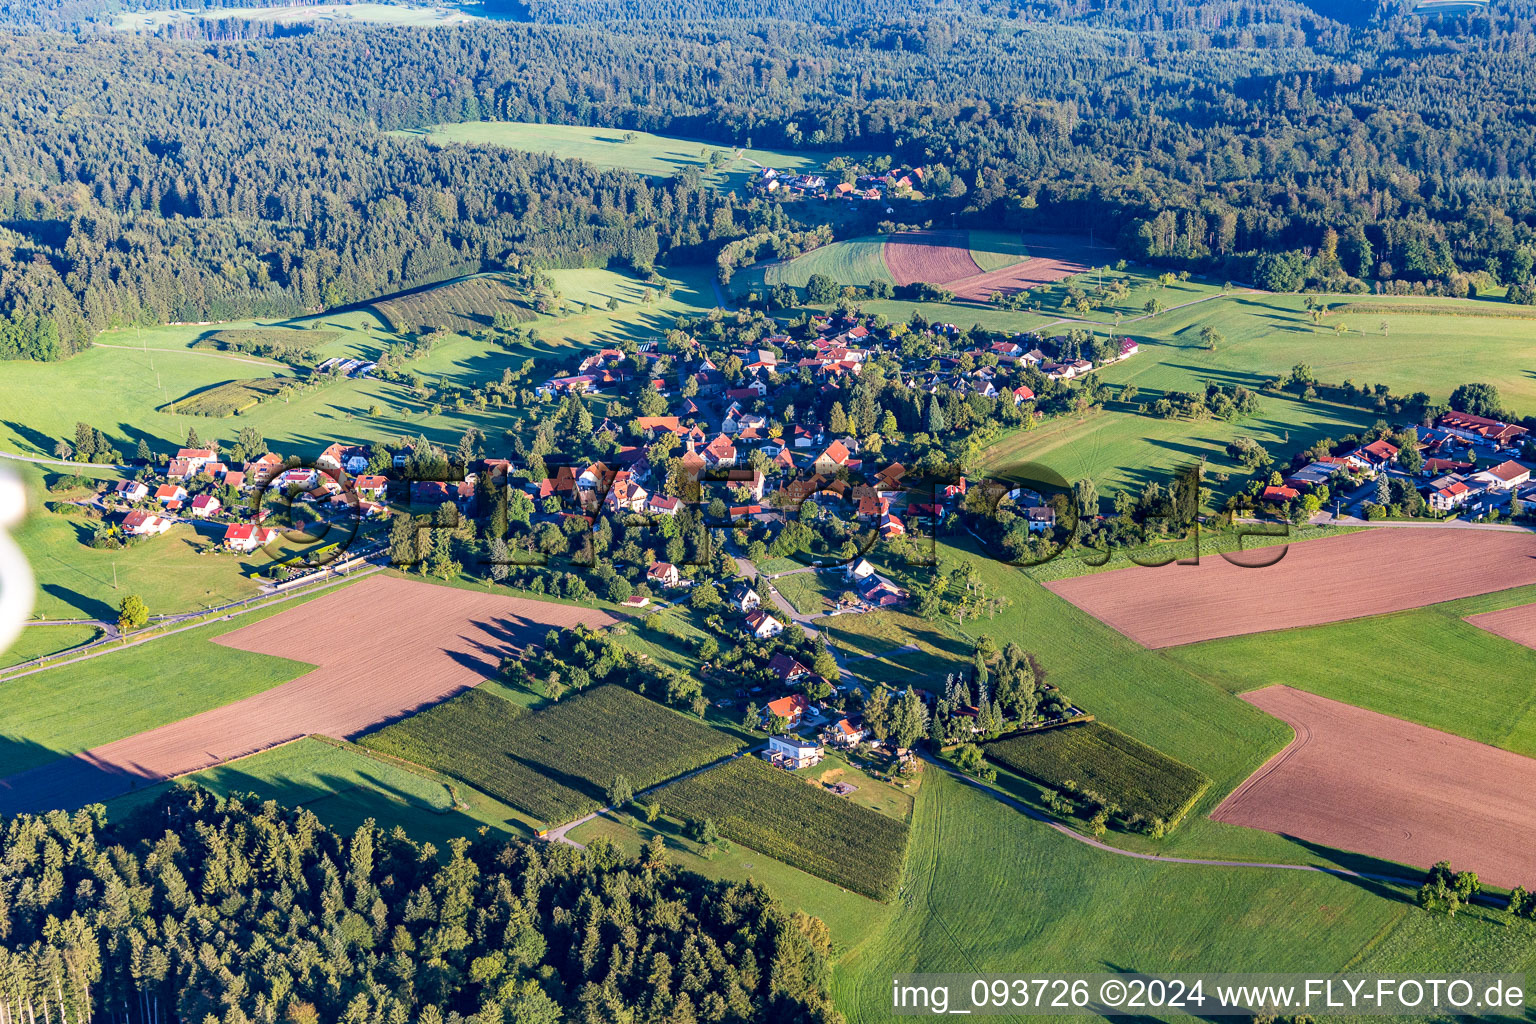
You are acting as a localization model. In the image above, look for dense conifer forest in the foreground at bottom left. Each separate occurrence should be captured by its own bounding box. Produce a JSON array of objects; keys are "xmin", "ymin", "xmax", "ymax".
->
[{"xmin": 0, "ymin": 786, "xmax": 842, "ymax": 1024}]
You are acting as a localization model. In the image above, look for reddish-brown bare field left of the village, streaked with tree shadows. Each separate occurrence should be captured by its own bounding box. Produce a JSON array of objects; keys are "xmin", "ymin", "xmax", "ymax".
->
[{"xmin": 0, "ymin": 576, "xmax": 613, "ymax": 814}]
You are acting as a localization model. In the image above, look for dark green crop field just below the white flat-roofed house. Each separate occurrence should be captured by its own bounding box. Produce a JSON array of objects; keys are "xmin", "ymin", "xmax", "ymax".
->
[{"xmin": 659, "ymin": 755, "xmax": 908, "ymax": 900}]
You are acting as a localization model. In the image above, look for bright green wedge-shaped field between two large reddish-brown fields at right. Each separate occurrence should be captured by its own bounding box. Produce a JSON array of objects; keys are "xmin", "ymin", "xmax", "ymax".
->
[{"xmin": 1166, "ymin": 586, "xmax": 1536, "ymax": 757}]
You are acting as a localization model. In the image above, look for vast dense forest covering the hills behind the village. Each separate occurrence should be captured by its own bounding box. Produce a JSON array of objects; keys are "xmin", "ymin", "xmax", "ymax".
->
[{"xmin": 0, "ymin": 0, "xmax": 1536, "ymax": 358}]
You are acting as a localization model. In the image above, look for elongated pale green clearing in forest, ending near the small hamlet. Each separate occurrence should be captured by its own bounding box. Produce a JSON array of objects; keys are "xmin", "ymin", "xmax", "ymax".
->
[{"xmin": 401, "ymin": 121, "xmax": 831, "ymax": 189}]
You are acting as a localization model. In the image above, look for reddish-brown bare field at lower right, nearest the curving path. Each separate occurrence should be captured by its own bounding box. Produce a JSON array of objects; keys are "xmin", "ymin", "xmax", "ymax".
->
[{"xmin": 1212, "ymin": 686, "xmax": 1536, "ymax": 887}]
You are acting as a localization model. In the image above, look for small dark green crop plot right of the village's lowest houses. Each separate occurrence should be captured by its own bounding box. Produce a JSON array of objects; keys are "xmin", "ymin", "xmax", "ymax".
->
[{"xmin": 983, "ymin": 722, "xmax": 1210, "ymax": 827}]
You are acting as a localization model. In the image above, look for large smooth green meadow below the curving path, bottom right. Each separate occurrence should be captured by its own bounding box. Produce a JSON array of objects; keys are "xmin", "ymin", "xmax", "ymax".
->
[{"xmin": 833, "ymin": 767, "xmax": 1536, "ymax": 1024}]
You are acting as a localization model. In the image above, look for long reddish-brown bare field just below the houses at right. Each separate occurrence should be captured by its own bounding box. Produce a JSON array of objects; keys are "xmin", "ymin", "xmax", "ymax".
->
[{"xmin": 1046, "ymin": 527, "xmax": 1536, "ymax": 648}]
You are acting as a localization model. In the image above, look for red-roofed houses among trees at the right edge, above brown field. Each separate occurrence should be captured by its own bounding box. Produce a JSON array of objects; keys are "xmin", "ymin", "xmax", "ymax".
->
[{"xmin": 1261, "ymin": 411, "xmax": 1536, "ymax": 514}]
